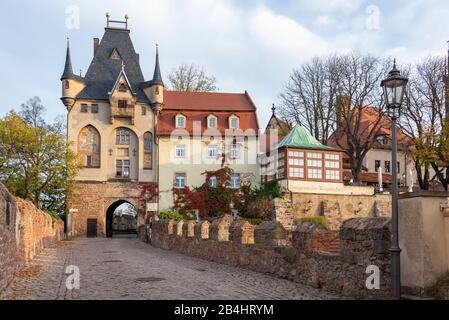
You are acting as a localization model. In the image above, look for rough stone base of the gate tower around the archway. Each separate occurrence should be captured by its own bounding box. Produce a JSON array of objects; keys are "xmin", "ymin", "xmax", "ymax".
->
[{"xmin": 69, "ymin": 182, "xmax": 144, "ymax": 237}]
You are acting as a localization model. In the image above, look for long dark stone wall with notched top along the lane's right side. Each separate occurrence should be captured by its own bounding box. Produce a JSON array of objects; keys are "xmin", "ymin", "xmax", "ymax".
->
[{"xmin": 151, "ymin": 217, "xmax": 390, "ymax": 298}]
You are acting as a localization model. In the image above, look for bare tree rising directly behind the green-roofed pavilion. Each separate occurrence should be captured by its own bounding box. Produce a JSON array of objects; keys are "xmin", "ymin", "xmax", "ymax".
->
[{"xmin": 280, "ymin": 55, "xmax": 337, "ymax": 143}]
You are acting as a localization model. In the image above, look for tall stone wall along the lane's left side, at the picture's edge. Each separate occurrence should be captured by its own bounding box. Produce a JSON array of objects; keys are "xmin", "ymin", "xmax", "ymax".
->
[{"xmin": 0, "ymin": 184, "xmax": 64, "ymax": 291}]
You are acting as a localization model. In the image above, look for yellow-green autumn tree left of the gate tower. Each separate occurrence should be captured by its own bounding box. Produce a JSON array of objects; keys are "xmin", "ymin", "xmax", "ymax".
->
[{"xmin": 0, "ymin": 98, "xmax": 79, "ymax": 214}]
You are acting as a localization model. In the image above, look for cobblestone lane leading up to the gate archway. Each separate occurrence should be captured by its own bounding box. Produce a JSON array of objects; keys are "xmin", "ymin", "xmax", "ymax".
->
[{"xmin": 0, "ymin": 238, "xmax": 335, "ymax": 300}]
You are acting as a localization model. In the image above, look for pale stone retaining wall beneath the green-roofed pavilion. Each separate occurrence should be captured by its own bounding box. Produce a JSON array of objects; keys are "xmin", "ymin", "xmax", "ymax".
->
[{"xmin": 272, "ymin": 193, "xmax": 391, "ymax": 231}]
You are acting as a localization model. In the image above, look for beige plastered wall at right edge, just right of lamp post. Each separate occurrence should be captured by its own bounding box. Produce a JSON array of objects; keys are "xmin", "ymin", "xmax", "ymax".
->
[{"xmin": 399, "ymin": 191, "xmax": 449, "ymax": 295}]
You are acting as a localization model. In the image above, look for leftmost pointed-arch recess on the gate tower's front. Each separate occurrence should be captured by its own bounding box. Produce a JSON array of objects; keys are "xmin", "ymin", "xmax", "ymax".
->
[{"xmin": 78, "ymin": 125, "xmax": 101, "ymax": 168}]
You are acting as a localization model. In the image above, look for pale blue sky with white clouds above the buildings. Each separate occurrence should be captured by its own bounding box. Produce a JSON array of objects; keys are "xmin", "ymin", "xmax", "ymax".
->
[{"xmin": 0, "ymin": 0, "xmax": 449, "ymax": 127}]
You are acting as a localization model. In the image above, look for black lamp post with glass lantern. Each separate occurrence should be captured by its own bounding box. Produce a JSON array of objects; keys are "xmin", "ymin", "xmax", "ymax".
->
[{"xmin": 381, "ymin": 60, "xmax": 408, "ymax": 300}]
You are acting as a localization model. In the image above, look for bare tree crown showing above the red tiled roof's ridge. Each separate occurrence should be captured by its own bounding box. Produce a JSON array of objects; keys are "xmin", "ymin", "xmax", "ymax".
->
[{"xmin": 168, "ymin": 64, "xmax": 218, "ymax": 92}]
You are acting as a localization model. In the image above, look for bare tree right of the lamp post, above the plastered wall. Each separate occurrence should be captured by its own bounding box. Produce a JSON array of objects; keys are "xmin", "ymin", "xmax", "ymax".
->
[{"xmin": 401, "ymin": 57, "xmax": 447, "ymax": 190}]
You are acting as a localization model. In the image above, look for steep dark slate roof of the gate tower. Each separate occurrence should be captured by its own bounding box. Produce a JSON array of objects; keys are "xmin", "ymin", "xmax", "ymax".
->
[{"xmin": 76, "ymin": 28, "xmax": 150, "ymax": 103}]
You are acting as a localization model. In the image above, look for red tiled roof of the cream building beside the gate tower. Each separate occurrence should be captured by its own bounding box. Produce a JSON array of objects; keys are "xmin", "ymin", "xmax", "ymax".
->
[{"xmin": 157, "ymin": 91, "xmax": 259, "ymax": 135}]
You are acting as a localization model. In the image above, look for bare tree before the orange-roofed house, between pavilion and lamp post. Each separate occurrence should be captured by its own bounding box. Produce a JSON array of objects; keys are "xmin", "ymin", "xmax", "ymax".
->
[{"xmin": 333, "ymin": 53, "xmax": 389, "ymax": 184}]
